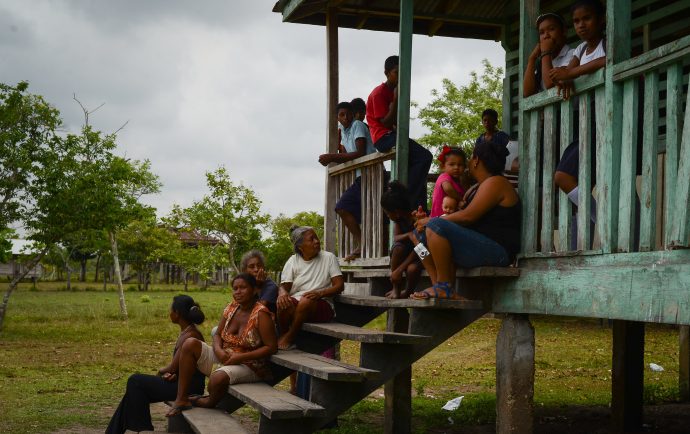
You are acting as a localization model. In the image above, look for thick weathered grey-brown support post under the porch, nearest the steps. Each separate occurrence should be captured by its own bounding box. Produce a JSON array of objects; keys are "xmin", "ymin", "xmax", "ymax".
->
[{"xmin": 496, "ymin": 314, "xmax": 534, "ymax": 434}]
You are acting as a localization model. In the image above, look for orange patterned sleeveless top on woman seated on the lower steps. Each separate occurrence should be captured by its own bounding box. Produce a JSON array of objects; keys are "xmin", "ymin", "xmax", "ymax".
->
[{"xmin": 220, "ymin": 301, "xmax": 273, "ymax": 380}]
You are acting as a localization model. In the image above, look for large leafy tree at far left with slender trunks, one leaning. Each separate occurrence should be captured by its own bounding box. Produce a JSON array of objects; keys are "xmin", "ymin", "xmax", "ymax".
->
[{"xmin": 0, "ymin": 91, "xmax": 160, "ymax": 328}]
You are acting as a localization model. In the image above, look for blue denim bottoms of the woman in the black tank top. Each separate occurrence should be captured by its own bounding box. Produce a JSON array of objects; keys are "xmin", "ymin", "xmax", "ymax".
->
[{"xmin": 420, "ymin": 217, "xmax": 510, "ymax": 268}]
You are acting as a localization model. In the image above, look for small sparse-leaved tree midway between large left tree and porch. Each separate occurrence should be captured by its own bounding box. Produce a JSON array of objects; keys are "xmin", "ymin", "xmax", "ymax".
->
[{"xmin": 165, "ymin": 167, "xmax": 269, "ymax": 272}]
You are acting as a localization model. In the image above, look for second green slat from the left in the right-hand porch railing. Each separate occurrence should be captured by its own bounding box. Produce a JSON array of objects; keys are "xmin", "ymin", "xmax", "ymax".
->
[{"xmin": 540, "ymin": 104, "xmax": 558, "ymax": 252}]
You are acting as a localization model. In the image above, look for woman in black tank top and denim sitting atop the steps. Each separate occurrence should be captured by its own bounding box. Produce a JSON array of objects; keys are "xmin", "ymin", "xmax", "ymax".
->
[{"xmin": 411, "ymin": 142, "xmax": 522, "ymax": 299}]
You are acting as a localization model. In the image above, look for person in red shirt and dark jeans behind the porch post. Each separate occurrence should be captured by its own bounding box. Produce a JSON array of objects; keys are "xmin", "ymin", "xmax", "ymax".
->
[{"xmin": 366, "ymin": 56, "xmax": 433, "ymax": 210}]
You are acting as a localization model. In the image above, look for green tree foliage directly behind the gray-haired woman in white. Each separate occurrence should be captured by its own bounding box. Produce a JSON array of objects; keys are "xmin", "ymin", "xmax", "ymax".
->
[{"xmin": 266, "ymin": 211, "xmax": 323, "ymax": 271}]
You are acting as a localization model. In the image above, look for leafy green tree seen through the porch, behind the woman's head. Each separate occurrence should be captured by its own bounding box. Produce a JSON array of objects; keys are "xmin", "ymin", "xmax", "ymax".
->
[{"xmin": 418, "ymin": 59, "xmax": 503, "ymax": 158}]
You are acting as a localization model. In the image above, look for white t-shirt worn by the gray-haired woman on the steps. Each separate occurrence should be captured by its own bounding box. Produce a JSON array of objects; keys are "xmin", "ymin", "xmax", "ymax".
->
[{"xmin": 280, "ymin": 250, "xmax": 343, "ymax": 307}]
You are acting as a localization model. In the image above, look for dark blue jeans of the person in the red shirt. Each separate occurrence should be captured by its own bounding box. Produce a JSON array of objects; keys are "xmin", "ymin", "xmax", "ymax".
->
[{"xmin": 374, "ymin": 131, "xmax": 434, "ymax": 212}]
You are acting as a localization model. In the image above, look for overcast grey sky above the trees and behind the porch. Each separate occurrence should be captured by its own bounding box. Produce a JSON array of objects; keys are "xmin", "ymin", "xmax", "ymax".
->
[{"xmin": 0, "ymin": 0, "xmax": 504, "ymax": 220}]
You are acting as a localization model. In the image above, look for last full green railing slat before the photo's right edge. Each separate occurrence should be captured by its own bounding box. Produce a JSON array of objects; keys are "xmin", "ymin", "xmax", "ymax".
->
[{"xmin": 664, "ymin": 62, "xmax": 683, "ymax": 246}]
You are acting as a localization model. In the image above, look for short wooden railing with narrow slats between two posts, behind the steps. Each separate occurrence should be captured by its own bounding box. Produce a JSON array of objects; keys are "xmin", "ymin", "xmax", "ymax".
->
[{"xmin": 328, "ymin": 149, "xmax": 395, "ymax": 258}]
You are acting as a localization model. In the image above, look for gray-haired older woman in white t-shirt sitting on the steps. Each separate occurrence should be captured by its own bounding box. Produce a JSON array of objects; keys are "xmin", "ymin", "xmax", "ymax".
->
[{"xmin": 277, "ymin": 226, "xmax": 344, "ymax": 350}]
